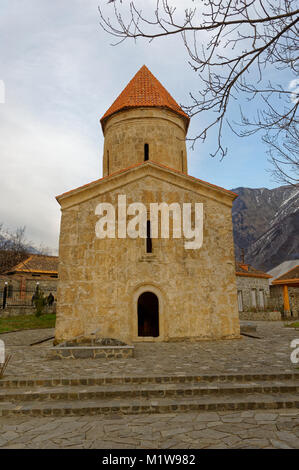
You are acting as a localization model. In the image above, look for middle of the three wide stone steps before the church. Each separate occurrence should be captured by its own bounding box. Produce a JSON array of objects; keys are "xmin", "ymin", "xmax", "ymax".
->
[{"xmin": 0, "ymin": 379, "xmax": 299, "ymax": 405}]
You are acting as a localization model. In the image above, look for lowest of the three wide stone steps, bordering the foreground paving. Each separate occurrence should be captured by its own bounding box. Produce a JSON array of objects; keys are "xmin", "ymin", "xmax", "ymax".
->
[{"xmin": 0, "ymin": 394, "xmax": 299, "ymax": 416}]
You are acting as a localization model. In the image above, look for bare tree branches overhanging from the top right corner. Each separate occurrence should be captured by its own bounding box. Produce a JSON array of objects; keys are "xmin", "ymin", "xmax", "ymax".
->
[{"xmin": 99, "ymin": 0, "xmax": 299, "ymax": 184}]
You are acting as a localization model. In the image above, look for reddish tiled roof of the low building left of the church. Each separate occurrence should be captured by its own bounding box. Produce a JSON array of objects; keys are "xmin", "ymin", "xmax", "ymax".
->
[{"xmin": 5, "ymin": 254, "xmax": 58, "ymax": 274}]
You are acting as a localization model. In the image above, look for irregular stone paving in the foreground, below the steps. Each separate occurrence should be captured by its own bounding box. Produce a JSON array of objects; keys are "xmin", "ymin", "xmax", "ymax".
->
[{"xmin": 0, "ymin": 410, "xmax": 299, "ymax": 449}]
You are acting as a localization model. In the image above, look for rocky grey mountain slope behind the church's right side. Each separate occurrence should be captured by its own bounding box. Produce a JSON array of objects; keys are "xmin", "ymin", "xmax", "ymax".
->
[{"xmin": 232, "ymin": 186, "xmax": 299, "ymax": 271}]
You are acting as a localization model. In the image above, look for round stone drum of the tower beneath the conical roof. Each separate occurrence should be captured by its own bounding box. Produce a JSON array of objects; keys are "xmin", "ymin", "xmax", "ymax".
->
[{"xmin": 103, "ymin": 108, "xmax": 187, "ymax": 176}]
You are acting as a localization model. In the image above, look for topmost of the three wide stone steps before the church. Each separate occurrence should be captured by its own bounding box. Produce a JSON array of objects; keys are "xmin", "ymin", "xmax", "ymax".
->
[{"xmin": 0, "ymin": 372, "xmax": 299, "ymax": 390}]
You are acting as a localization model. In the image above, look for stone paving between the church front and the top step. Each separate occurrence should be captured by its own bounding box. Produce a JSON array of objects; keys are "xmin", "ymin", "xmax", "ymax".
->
[{"xmin": 0, "ymin": 322, "xmax": 299, "ymax": 378}]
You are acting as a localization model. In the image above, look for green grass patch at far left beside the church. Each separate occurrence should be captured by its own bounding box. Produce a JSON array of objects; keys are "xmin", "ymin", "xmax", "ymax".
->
[{"xmin": 0, "ymin": 313, "xmax": 56, "ymax": 333}]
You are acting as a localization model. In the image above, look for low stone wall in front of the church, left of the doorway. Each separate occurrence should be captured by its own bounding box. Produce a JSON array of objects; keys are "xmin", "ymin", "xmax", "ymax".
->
[{"xmin": 50, "ymin": 346, "xmax": 134, "ymax": 359}]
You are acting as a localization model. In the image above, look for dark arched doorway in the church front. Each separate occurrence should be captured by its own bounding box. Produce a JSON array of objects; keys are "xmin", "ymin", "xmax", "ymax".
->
[{"xmin": 137, "ymin": 292, "xmax": 159, "ymax": 337}]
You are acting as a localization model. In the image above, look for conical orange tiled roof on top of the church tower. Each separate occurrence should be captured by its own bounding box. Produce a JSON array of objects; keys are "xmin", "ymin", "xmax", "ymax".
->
[{"xmin": 101, "ymin": 65, "xmax": 190, "ymax": 127}]
